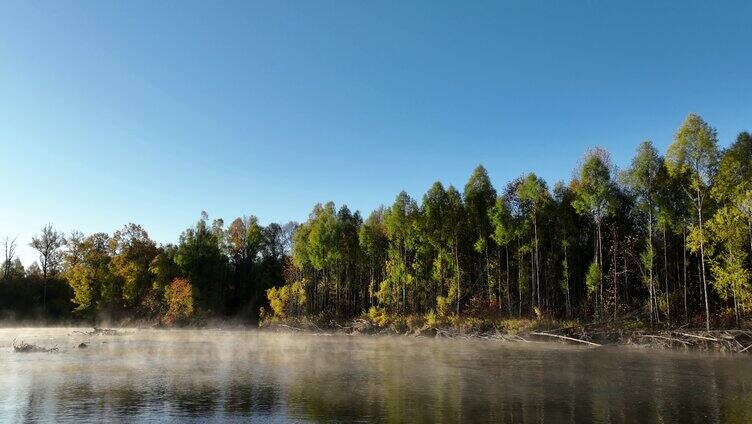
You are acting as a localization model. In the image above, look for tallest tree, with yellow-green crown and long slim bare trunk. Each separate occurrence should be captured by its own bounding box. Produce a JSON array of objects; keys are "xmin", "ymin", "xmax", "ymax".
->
[{"xmin": 666, "ymin": 114, "xmax": 719, "ymax": 331}]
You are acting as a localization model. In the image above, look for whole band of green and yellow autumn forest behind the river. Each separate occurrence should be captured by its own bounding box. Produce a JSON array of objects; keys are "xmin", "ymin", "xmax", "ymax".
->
[{"xmin": 0, "ymin": 114, "xmax": 752, "ymax": 329}]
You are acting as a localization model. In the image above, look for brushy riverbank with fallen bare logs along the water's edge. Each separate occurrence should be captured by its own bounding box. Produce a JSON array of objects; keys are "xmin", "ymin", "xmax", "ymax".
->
[{"xmin": 259, "ymin": 315, "xmax": 752, "ymax": 354}]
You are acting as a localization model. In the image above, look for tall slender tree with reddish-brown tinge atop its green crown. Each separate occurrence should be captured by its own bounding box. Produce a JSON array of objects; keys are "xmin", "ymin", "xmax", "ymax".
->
[{"xmin": 572, "ymin": 148, "xmax": 613, "ymax": 309}]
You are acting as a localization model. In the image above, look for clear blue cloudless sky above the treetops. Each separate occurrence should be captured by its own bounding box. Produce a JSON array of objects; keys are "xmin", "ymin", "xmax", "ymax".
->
[{"xmin": 0, "ymin": 0, "xmax": 752, "ymax": 265}]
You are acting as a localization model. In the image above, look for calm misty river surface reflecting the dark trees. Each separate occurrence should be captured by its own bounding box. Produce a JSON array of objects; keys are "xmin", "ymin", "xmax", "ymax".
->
[{"xmin": 0, "ymin": 328, "xmax": 752, "ymax": 423}]
